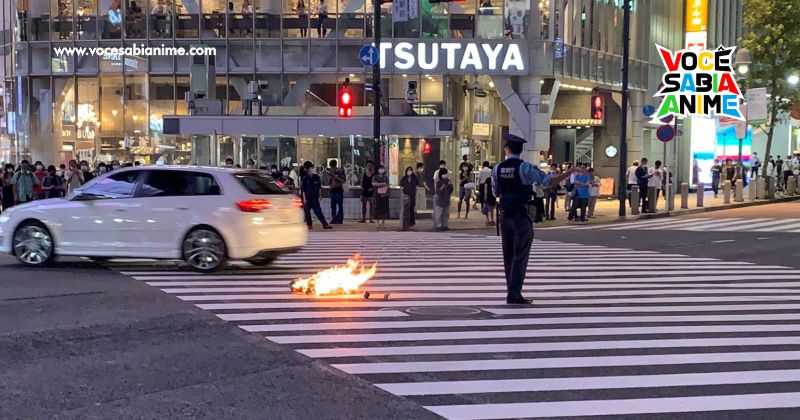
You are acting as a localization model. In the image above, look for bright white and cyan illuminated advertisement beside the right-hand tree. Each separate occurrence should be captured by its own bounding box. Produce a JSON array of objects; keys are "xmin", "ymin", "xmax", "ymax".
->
[{"xmin": 686, "ymin": 117, "xmax": 753, "ymax": 185}]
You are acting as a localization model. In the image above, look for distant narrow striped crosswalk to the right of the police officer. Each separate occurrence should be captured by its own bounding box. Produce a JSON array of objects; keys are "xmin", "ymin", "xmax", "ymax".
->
[{"xmin": 538, "ymin": 217, "xmax": 800, "ymax": 233}]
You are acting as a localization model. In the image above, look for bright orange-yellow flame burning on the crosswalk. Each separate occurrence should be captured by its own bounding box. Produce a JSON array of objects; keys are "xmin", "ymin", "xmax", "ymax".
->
[{"xmin": 290, "ymin": 254, "xmax": 378, "ymax": 296}]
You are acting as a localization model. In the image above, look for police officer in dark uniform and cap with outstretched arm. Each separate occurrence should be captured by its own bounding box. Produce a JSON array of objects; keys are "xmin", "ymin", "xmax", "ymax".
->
[{"xmin": 492, "ymin": 134, "xmax": 572, "ymax": 304}]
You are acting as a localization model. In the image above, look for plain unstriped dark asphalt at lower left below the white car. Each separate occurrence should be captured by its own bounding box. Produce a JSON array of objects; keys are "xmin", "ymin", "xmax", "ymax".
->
[{"xmin": 0, "ymin": 256, "xmax": 436, "ymax": 419}]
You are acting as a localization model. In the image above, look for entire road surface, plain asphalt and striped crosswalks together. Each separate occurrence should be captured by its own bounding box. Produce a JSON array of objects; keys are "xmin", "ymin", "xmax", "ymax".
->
[{"xmin": 0, "ymin": 203, "xmax": 800, "ymax": 419}]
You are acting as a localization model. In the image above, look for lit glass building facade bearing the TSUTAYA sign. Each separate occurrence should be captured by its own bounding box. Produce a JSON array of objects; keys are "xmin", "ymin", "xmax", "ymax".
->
[{"xmin": 0, "ymin": 0, "xmax": 741, "ymax": 187}]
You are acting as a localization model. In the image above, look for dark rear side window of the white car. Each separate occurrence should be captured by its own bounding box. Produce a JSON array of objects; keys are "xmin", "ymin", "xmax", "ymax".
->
[{"xmin": 137, "ymin": 171, "xmax": 221, "ymax": 197}]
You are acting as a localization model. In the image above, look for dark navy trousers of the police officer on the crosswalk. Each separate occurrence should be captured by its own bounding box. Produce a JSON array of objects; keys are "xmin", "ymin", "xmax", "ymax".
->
[{"xmin": 500, "ymin": 216, "xmax": 533, "ymax": 300}]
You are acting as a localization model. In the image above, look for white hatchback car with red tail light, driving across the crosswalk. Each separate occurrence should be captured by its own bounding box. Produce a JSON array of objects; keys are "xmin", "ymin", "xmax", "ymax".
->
[{"xmin": 0, "ymin": 166, "xmax": 308, "ymax": 272}]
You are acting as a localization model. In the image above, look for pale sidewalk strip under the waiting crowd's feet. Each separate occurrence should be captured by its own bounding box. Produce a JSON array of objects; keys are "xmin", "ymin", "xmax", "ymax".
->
[{"xmin": 314, "ymin": 189, "xmax": 800, "ymax": 234}]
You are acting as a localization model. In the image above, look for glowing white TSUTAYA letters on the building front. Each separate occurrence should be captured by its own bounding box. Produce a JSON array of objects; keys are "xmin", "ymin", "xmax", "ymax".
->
[{"xmin": 379, "ymin": 41, "xmax": 528, "ymax": 75}]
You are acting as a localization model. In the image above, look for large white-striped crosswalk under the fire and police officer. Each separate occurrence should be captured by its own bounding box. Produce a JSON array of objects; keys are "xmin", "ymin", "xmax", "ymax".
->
[{"xmin": 109, "ymin": 232, "xmax": 800, "ymax": 419}]
